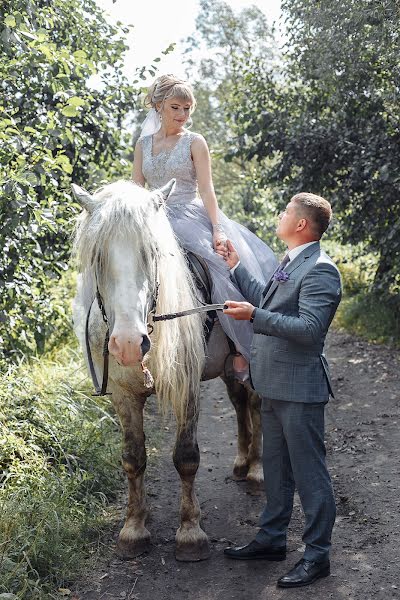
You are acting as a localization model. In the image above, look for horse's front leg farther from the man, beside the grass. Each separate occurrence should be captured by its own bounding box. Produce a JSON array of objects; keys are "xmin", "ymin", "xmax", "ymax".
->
[{"xmin": 113, "ymin": 392, "xmax": 150, "ymax": 559}]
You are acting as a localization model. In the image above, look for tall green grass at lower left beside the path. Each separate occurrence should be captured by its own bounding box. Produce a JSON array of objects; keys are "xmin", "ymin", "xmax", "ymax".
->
[{"xmin": 0, "ymin": 347, "xmax": 121, "ymax": 599}]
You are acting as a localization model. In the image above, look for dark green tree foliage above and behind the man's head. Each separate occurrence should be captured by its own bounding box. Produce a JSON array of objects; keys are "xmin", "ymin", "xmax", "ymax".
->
[{"xmin": 228, "ymin": 0, "xmax": 400, "ymax": 307}]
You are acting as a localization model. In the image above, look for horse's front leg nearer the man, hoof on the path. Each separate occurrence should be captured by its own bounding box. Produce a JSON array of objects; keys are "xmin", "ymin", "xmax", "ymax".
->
[{"xmin": 174, "ymin": 400, "xmax": 210, "ymax": 561}]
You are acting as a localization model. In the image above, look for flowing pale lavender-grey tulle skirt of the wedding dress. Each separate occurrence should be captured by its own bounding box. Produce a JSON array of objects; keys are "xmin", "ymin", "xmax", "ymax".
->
[{"xmin": 167, "ymin": 198, "xmax": 278, "ymax": 360}]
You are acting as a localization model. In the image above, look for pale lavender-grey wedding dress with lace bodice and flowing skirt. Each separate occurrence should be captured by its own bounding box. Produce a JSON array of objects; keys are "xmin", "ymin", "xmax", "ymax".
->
[{"xmin": 141, "ymin": 131, "xmax": 277, "ymax": 360}]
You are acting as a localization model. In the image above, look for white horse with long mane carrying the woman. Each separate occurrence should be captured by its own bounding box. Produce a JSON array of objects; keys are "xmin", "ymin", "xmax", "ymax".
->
[{"xmin": 73, "ymin": 181, "xmax": 262, "ymax": 561}]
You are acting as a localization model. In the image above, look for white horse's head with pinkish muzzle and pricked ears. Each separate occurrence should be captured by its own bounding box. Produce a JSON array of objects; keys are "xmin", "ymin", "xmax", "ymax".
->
[{"xmin": 72, "ymin": 180, "xmax": 174, "ymax": 366}]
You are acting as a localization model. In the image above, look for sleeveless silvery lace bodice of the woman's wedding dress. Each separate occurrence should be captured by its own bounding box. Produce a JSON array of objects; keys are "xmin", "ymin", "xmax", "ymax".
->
[{"xmin": 141, "ymin": 131, "xmax": 199, "ymax": 205}]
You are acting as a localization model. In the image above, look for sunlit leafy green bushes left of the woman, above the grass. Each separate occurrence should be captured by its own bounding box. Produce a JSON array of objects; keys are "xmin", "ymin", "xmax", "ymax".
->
[{"xmin": 0, "ymin": 0, "xmax": 152, "ymax": 357}]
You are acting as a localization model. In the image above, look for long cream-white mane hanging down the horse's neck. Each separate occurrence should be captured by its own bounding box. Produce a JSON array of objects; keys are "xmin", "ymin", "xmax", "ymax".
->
[{"xmin": 75, "ymin": 181, "xmax": 204, "ymax": 426}]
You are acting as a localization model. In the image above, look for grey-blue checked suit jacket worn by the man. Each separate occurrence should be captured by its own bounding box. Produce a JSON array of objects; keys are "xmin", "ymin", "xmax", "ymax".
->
[{"xmin": 233, "ymin": 242, "xmax": 342, "ymax": 402}]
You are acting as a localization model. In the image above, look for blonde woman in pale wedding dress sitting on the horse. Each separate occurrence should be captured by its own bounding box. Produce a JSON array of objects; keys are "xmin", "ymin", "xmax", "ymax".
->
[{"xmin": 133, "ymin": 75, "xmax": 277, "ymax": 381}]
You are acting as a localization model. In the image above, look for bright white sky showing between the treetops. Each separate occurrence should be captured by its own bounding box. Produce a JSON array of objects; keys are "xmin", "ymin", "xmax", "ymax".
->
[{"xmin": 96, "ymin": 0, "xmax": 281, "ymax": 85}]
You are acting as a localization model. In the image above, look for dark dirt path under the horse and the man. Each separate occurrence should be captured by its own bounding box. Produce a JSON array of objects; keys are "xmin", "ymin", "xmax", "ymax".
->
[{"xmin": 75, "ymin": 332, "xmax": 400, "ymax": 600}]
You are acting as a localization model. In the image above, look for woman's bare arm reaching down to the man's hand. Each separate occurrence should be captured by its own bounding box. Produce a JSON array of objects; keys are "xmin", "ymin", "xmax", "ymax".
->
[{"xmin": 191, "ymin": 136, "xmax": 226, "ymax": 256}]
